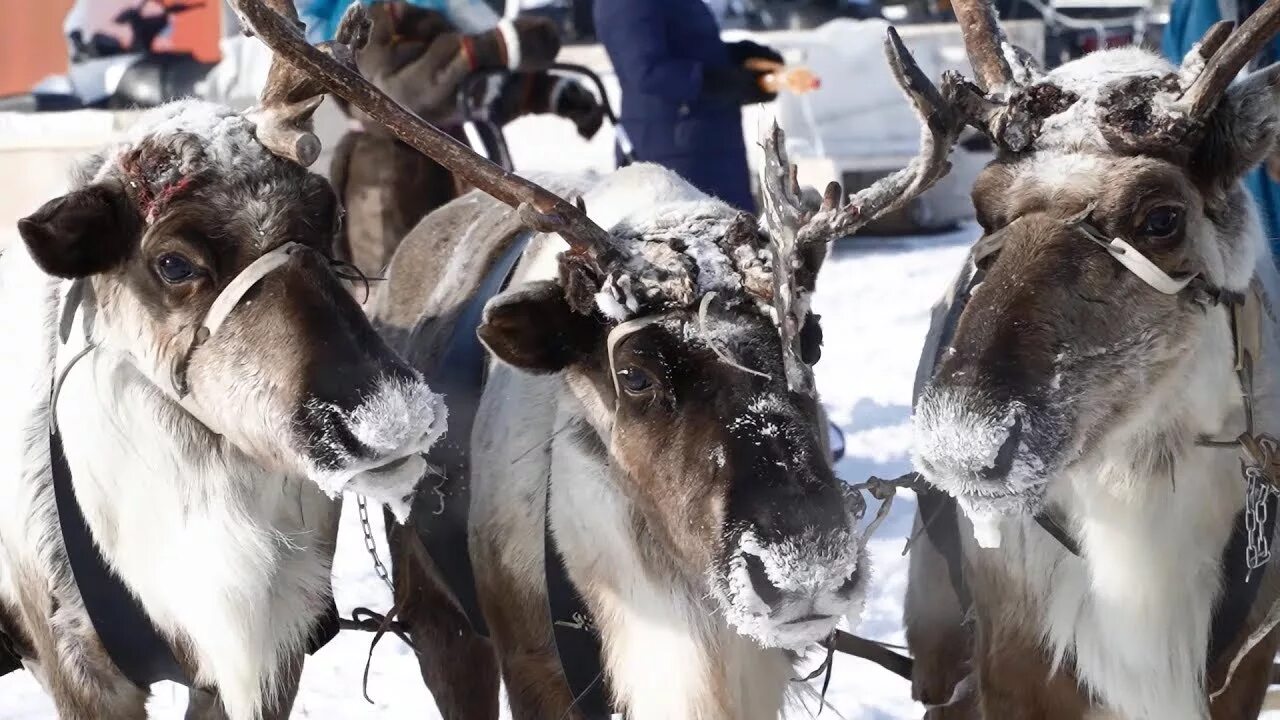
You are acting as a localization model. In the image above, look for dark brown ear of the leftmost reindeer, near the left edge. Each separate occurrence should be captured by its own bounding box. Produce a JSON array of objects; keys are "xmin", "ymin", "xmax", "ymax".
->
[{"xmin": 18, "ymin": 182, "xmax": 142, "ymax": 278}]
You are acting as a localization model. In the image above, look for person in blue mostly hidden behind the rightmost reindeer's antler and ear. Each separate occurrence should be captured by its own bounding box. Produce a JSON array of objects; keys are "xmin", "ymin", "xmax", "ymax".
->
[{"xmin": 1164, "ymin": 0, "xmax": 1280, "ymax": 258}]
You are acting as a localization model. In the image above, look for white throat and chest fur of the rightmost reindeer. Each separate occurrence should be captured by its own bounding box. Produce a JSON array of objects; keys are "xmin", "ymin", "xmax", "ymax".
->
[{"xmin": 962, "ymin": 307, "xmax": 1243, "ymax": 720}]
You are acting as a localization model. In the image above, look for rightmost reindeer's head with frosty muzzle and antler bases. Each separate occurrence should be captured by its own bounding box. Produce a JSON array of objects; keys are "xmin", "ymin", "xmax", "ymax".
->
[{"xmin": 915, "ymin": 0, "xmax": 1280, "ymax": 515}]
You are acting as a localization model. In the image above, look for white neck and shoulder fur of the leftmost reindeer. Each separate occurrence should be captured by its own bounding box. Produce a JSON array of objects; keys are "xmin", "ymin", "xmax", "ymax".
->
[{"xmin": 0, "ymin": 246, "xmax": 337, "ymax": 720}]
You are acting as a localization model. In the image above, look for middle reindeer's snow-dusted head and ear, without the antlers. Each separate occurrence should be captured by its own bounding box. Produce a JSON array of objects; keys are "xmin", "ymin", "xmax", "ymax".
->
[{"xmin": 479, "ymin": 165, "xmax": 868, "ymax": 647}]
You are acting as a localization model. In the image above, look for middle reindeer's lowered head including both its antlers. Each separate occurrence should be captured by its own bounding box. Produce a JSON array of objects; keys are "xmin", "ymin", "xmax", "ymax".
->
[{"xmin": 225, "ymin": 0, "xmax": 959, "ymax": 646}]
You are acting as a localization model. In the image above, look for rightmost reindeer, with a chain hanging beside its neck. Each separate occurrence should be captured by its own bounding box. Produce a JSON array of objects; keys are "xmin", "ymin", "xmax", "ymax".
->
[{"xmin": 906, "ymin": 0, "xmax": 1280, "ymax": 720}]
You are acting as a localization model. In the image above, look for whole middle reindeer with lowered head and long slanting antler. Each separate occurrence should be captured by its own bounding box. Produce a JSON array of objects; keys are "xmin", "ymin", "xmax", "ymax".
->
[{"xmin": 225, "ymin": 0, "xmax": 959, "ymax": 719}]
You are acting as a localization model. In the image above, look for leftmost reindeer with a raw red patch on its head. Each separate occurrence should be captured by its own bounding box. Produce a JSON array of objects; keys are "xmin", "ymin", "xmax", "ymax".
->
[{"xmin": 0, "ymin": 3, "xmax": 445, "ymax": 720}]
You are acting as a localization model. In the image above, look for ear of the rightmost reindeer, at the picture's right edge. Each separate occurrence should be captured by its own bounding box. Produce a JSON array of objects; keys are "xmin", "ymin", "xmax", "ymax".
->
[{"xmin": 1192, "ymin": 63, "xmax": 1280, "ymax": 186}]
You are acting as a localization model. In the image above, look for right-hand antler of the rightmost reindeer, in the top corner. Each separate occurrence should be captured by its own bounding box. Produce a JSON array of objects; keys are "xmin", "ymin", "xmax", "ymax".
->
[{"xmin": 1180, "ymin": 0, "xmax": 1280, "ymax": 119}]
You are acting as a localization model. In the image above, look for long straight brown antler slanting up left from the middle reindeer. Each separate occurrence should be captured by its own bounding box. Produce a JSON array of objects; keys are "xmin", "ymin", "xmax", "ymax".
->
[{"xmin": 228, "ymin": 0, "xmax": 627, "ymax": 269}]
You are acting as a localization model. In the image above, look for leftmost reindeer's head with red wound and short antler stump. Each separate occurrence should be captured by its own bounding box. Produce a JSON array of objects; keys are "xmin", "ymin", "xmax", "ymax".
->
[{"xmin": 18, "ymin": 1, "xmax": 444, "ymax": 514}]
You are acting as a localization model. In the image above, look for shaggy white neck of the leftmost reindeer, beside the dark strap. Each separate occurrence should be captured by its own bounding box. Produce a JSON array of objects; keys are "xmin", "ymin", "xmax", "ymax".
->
[{"xmin": 58, "ymin": 340, "xmax": 337, "ymax": 717}]
